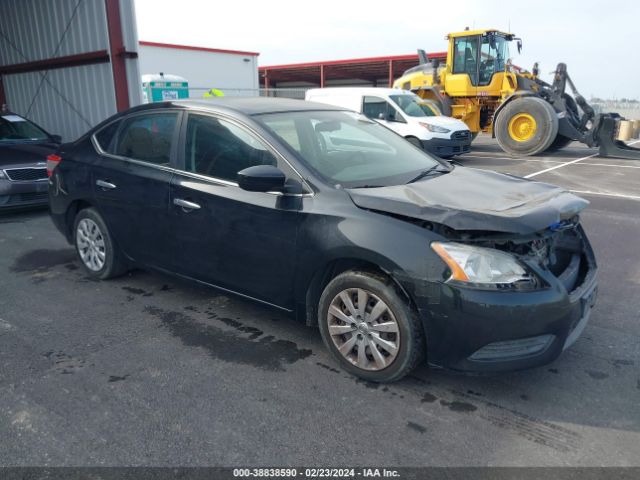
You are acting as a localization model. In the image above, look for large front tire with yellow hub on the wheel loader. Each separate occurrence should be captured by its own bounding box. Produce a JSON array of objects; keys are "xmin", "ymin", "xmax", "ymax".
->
[{"xmin": 495, "ymin": 97, "xmax": 558, "ymax": 155}]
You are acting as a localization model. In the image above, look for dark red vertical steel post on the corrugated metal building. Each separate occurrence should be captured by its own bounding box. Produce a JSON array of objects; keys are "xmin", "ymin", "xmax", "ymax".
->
[{"xmin": 104, "ymin": 0, "xmax": 129, "ymax": 112}]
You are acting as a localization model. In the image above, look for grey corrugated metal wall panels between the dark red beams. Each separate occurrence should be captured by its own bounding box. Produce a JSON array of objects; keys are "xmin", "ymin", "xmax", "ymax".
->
[{"xmin": 0, "ymin": 0, "xmax": 140, "ymax": 141}]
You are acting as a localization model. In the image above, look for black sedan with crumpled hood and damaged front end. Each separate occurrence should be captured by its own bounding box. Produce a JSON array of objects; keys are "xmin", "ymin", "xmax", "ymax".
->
[{"xmin": 49, "ymin": 98, "xmax": 596, "ymax": 382}]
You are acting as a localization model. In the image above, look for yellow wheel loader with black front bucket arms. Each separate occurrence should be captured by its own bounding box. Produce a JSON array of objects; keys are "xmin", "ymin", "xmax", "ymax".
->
[{"xmin": 393, "ymin": 30, "xmax": 640, "ymax": 159}]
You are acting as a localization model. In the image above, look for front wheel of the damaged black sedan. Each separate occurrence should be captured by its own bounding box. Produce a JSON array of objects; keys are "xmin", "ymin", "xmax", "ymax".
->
[{"xmin": 318, "ymin": 270, "xmax": 426, "ymax": 383}]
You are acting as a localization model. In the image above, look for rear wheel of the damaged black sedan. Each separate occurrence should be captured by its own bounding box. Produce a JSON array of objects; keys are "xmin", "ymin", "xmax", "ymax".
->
[{"xmin": 73, "ymin": 208, "xmax": 127, "ymax": 280}]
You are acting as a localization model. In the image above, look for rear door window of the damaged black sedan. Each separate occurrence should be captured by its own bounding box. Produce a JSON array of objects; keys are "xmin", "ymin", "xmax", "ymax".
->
[{"xmin": 107, "ymin": 112, "xmax": 178, "ymax": 166}]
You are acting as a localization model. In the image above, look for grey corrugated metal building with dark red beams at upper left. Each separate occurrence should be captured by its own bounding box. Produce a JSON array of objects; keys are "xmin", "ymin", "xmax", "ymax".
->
[{"xmin": 0, "ymin": 0, "xmax": 141, "ymax": 140}]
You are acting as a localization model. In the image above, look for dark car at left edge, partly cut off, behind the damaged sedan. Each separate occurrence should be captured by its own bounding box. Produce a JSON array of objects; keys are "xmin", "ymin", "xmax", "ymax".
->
[{"xmin": 0, "ymin": 110, "xmax": 60, "ymax": 210}]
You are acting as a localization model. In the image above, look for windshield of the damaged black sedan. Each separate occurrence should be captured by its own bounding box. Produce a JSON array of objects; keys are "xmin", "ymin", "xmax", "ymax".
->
[{"xmin": 256, "ymin": 111, "xmax": 441, "ymax": 188}]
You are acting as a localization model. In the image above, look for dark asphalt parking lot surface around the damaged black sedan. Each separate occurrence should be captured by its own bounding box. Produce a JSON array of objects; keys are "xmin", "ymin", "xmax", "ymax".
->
[{"xmin": 0, "ymin": 137, "xmax": 640, "ymax": 466}]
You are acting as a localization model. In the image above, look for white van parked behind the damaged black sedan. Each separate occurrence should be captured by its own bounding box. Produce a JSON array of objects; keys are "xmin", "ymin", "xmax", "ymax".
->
[{"xmin": 305, "ymin": 87, "xmax": 472, "ymax": 158}]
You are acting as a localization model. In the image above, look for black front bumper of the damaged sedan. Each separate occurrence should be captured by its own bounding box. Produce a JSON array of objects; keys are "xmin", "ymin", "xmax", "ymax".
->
[{"xmin": 408, "ymin": 225, "xmax": 598, "ymax": 372}]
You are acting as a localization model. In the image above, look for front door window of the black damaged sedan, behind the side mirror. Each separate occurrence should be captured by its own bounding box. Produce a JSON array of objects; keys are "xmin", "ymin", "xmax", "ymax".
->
[{"xmin": 184, "ymin": 114, "xmax": 277, "ymax": 182}]
